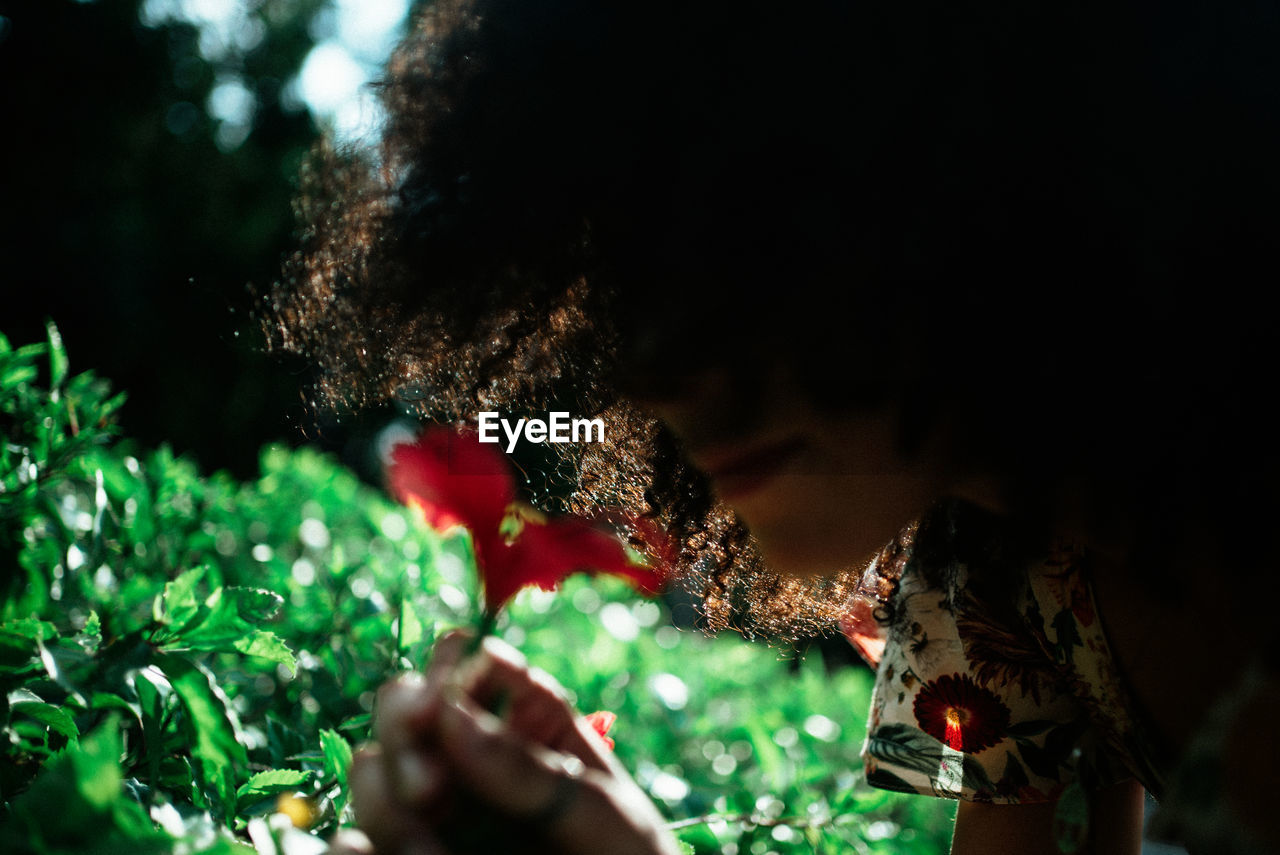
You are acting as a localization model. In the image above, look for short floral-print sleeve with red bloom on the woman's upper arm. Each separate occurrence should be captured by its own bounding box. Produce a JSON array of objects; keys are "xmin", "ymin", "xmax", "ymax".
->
[{"xmin": 846, "ymin": 547, "xmax": 1116, "ymax": 804}]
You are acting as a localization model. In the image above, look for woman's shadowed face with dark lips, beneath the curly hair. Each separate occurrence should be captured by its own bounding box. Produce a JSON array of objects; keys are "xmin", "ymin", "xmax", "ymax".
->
[{"xmin": 629, "ymin": 344, "xmax": 950, "ymax": 576}]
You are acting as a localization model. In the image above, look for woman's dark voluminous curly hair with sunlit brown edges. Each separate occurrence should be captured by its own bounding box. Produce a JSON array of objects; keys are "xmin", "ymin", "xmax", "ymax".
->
[{"xmin": 266, "ymin": 0, "xmax": 1280, "ymax": 636}]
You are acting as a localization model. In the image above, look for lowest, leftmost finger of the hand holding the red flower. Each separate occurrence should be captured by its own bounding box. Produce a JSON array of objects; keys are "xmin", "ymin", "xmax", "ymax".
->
[{"xmin": 349, "ymin": 745, "xmax": 445, "ymax": 855}]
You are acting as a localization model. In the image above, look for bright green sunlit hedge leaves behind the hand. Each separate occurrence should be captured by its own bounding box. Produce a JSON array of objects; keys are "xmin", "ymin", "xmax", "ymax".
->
[{"xmin": 0, "ymin": 326, "xmax": 952, "ymax": 855}]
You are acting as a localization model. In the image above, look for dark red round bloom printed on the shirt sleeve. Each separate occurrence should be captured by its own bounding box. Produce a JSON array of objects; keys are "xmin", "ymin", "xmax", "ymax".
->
[{"xmin": 913, "ymin": 675, "xmax": 1009, "ymax": 754}]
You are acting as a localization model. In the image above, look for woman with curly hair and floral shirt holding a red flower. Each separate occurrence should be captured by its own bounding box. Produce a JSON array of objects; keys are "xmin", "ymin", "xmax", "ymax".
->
[{"xmin": 273, "ymin": 0, "xmax": 1280, "ymax": 854}]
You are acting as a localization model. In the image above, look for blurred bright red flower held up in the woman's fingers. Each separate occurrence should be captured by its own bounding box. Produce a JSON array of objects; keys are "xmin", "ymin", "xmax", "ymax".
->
[{"xmin": 387, "ymin": 428, "xmax": 662, "ymax": 613}]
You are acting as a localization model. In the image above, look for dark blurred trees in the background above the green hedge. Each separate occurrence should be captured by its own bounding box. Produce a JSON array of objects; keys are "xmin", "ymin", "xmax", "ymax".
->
[{"xmin": 0, "ymin": 0, "xmax": 350, "ymax": 474}]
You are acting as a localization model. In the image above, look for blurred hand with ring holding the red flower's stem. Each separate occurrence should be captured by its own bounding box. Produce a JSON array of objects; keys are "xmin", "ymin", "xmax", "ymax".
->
[{"xmin": 332, "ymin": 634, "xmax": 680, "ymax": 855}]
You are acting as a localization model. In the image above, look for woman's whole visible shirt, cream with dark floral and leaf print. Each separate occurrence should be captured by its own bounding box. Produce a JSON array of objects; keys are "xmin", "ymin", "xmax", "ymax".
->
[{"xmin": 842, "ymin": 502, "xmax": 1164, "ymax": 852}]
